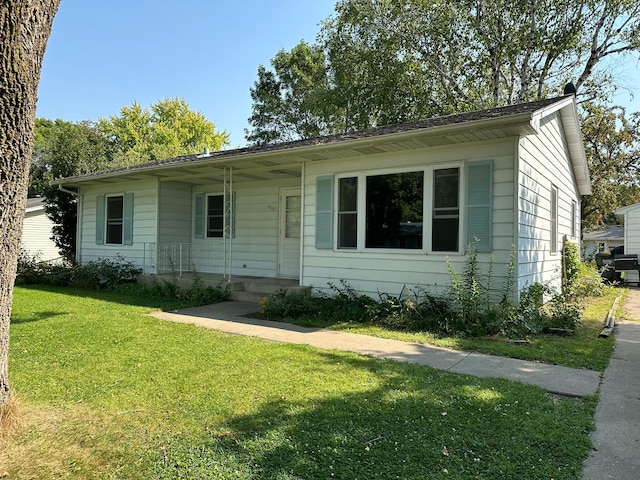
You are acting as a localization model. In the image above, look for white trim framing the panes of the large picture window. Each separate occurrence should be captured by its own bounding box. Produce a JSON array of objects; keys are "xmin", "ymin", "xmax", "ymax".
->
[{"xmin": 332, "ymin": 164, "xmax": 466, "ymax": 255}]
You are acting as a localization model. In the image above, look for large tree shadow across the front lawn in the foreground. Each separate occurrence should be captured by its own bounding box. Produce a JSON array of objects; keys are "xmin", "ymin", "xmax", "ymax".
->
[{"xmin": 152, "ymin": 353, "xmax": 590, "ymax": 479}]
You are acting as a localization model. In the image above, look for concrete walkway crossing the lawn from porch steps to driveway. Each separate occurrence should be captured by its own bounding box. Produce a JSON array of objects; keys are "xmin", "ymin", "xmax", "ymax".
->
[{"xmin": 154, "ymin": 302, "xmax": 604, "ymax": 398}]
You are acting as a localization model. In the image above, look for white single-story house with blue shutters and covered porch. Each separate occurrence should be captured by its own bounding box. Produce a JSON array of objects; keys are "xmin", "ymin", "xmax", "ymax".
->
[{"xmin": 60, "ymin": 96, "xmax": 590, "ymax": 296}]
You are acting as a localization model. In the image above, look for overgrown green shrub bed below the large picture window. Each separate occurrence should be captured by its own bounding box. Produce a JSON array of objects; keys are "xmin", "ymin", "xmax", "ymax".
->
[{"xmin": 260, "ymin": 239, "xmax": 597, "ymax": 339}]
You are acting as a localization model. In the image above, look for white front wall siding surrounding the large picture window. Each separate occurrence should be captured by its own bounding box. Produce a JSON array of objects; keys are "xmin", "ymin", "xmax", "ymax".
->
[{"xmin": 301, "ymin": 140, "xmax": 515, "ymax": 297}]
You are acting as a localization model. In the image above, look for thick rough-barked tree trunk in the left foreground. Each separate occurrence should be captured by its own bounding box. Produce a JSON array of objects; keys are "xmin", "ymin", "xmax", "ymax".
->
[{"xmin": 0, "ymin": 0, "xmax": 60, "ymax": 419}]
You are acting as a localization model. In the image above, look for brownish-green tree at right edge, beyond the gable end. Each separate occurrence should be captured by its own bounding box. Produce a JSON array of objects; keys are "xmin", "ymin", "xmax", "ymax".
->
[{"xmin": 582, "ymin": 103, "xmax": 640, "ymax": 227}]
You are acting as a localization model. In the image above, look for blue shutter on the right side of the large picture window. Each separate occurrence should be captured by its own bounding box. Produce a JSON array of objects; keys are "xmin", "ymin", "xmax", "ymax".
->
[{"xmin": 467, "ymin": 161, "xmax": 493, "ymax": 252}]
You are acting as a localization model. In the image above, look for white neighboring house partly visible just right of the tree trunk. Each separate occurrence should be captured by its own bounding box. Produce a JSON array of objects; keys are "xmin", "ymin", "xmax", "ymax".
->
[{"xmin": 21, "ymin": 198, "xmax": 60, "ymax": 262}]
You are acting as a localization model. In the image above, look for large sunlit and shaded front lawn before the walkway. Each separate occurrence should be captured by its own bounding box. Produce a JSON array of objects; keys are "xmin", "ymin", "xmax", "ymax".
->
[{"xmin": 0, "ymin": 287, "xmax": 596, "ymax": 480}]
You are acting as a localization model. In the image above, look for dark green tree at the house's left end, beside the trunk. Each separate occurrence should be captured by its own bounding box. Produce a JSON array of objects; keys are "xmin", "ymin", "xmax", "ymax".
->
[{"xmin": 29, "ymin": 118, "xmax": 114, "ymax": 261}]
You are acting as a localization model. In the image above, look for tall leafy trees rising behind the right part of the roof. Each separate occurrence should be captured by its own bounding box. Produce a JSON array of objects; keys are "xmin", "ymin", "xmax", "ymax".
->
[{"xmin": 247, "ymin": 0, "xmax": 640, "ymax": 143}]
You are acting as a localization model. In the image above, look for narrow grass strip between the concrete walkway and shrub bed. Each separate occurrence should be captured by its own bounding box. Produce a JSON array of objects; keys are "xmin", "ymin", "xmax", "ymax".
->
[{"xmin": 268, "ymin": 288, "xmax": 626, "ymax": 372}]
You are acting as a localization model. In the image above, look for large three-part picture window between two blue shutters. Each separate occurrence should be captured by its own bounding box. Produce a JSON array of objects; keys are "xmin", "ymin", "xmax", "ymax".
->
[{"xmin": 336, "ymin": 167, "xmax": 462, "ymax": 252}]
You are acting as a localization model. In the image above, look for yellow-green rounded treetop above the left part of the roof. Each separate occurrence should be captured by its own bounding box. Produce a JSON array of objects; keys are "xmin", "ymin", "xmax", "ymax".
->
[{"xmin": 98, "ymin": 98, "xmax": 229, "ymax": 167}]
